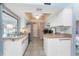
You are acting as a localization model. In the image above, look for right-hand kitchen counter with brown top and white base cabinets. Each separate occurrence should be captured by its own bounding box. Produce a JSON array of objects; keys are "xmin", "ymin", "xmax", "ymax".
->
[{"xmin": 43, "ymin": 34, "xmax": 72, "ymax": 56}]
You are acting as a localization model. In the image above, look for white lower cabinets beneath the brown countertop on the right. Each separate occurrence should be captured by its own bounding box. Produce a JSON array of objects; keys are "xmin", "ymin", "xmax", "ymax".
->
[{"xmin": 44, "ymin": 38, "xmax": 71, "ymax": 56}]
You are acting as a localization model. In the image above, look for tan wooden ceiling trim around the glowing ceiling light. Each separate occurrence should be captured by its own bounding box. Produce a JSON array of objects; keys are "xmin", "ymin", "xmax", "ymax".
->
[{"xmin": 25, "ymin": 12, "xmax": 50, "ymax": 22}]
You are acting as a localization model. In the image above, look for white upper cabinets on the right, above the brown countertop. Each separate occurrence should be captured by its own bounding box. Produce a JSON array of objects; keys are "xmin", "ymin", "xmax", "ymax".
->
[{"xmin": 50, "ymin": 7, "xmax": 72, "ymax": 27}]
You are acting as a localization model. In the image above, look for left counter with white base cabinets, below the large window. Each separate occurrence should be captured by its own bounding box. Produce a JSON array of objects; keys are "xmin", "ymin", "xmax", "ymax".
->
[{"xmin": 3, "ymin": 34, "xmax": 28, "ymax": 56}]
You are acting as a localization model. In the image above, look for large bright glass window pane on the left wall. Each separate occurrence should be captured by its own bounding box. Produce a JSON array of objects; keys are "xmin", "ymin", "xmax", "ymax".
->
[{"xmin": 3, "ymin": 13, "xmax": 17, "ymax": 37}]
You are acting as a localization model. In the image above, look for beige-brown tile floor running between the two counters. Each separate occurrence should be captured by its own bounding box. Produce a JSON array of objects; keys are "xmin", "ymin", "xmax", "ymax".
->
[{"xmin": 24, "ymin": 38, "xmax": 45, "ymax": 56}]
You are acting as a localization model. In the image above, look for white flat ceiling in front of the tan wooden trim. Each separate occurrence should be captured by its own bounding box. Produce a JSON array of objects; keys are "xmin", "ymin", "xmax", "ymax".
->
[{"xmin": 5, "ymin": 3, "xmax": 69, "ymax": 18}]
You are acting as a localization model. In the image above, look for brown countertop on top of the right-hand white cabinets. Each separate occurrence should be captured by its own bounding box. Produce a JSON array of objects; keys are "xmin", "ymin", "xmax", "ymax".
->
[{"xmin": 44, "ymin": 34, "xmax": 72, "ymax": 38}]
